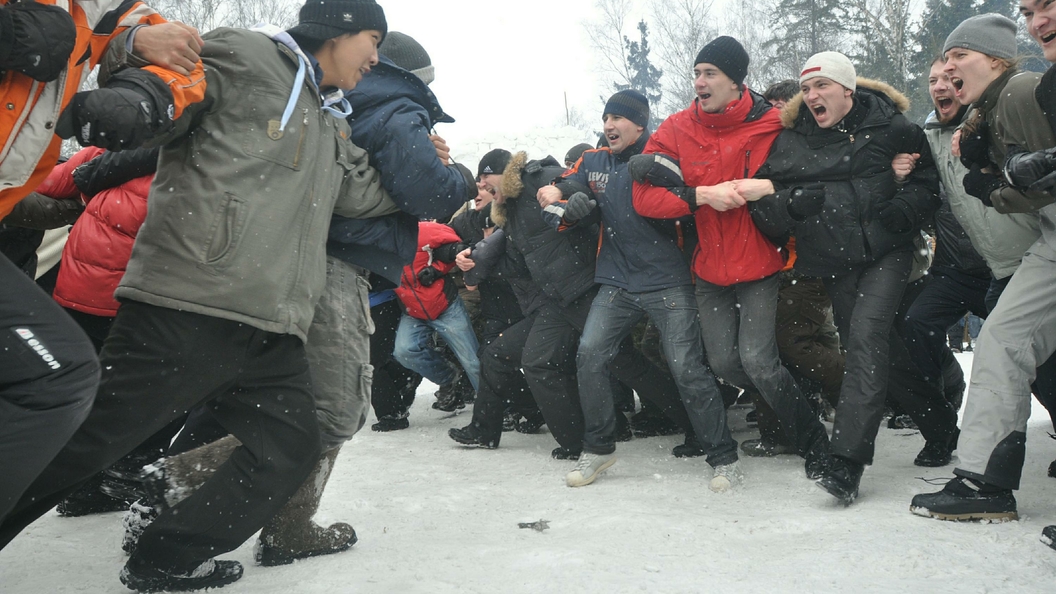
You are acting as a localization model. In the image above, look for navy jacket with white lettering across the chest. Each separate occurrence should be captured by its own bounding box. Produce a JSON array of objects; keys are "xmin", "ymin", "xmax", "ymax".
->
[{"xmin": 543, "ymin": 133, "xmax": 693, "ymax": 293}]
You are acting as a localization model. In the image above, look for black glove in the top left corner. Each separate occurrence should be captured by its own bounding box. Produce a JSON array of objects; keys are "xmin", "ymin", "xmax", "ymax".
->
[{"xmin": 0, "ymin": 2, "xmax": 77, "ymax": 82}]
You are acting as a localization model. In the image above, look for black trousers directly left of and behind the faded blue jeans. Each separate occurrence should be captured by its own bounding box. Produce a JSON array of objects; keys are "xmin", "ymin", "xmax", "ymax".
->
[{"xmin": 521, "ymin": 289, "xmax": 690, "ymax": 451}]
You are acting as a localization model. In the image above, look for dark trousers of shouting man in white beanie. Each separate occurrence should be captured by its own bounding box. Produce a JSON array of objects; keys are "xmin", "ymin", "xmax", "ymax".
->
[{"xmin": 825, "ymin": 249, "xmax": 912, "ymax": 464}]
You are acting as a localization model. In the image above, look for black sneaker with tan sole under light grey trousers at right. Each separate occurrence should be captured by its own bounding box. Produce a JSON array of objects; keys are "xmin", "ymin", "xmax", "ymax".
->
[{"xmin": 909, "ymin": 477, "xmax": 1019, "ymax": 522}]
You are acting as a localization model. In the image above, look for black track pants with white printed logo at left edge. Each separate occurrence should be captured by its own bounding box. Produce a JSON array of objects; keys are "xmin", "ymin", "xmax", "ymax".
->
[{"xmin": 0, "ymin": 256, "xmax": 99, "ymax": 524}]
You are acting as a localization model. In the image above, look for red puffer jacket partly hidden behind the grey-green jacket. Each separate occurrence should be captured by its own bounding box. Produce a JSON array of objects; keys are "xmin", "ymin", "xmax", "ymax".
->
[{"xmin": 37, "ymin": 147, "xmax": 153, "ymax": 317}]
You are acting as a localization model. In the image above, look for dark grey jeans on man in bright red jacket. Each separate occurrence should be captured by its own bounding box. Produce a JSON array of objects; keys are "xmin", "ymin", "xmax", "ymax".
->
[{"xmin": 696, "ymin": 275, "xmax": 828, "ymax": 456}]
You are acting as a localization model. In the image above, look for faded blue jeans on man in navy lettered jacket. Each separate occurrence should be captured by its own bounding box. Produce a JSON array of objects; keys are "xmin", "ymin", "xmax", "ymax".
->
[{"xmin": 576, "ymin": 285, "xmax": 737, "ymax": 466}]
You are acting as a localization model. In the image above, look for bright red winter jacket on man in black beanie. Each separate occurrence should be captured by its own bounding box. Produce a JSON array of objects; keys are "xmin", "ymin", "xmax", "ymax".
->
[{"xmin": 635, "ymin": 88, "xmax": 785, "ymax": 286}]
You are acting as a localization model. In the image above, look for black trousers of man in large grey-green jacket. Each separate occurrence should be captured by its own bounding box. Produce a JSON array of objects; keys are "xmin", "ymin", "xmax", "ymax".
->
[{"xmin": 0, "ymin": 301, "xmax": 321, "ymax": 572}]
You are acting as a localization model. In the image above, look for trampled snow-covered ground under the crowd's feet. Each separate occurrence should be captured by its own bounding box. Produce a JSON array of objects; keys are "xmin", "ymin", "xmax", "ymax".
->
[{"xmin": 0, "ymin": 355, "xmax": 1056, "ymax": 594}]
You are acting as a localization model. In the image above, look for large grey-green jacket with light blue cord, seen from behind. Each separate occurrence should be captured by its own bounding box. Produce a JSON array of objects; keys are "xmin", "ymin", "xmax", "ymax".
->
[{"xmin": 115, "ymin": 27, "xmax": 397, "ymax": 340}]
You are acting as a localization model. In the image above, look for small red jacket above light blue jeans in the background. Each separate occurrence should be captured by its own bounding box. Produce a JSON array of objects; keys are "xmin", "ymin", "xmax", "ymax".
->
[{"xmin": 396, "ymin": 222, "xmax": 461, "ymax": 320}]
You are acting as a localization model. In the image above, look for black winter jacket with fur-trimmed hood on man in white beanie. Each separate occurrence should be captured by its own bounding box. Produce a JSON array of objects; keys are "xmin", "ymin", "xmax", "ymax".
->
[{"xmin": 750, "ymin": 78, "xmax": 939, "ymax": 277}]
